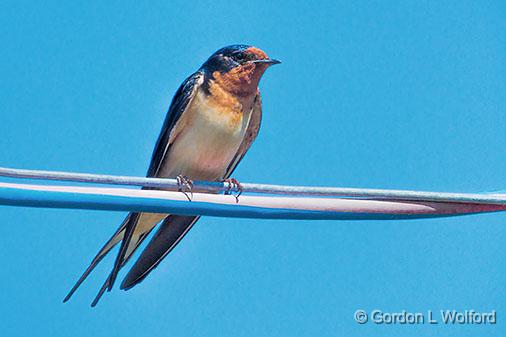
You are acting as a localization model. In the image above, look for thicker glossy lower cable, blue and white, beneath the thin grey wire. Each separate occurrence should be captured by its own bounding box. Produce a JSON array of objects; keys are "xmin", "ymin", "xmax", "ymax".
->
[{"xmin": 0, "ymin": 182, "xmax": 506, "ymax": 220}]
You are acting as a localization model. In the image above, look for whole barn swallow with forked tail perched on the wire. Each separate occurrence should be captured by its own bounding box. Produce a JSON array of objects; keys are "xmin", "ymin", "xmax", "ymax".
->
[{"xmin": 63, "ymin": 45, "xmax": 280, "ymax": 306}]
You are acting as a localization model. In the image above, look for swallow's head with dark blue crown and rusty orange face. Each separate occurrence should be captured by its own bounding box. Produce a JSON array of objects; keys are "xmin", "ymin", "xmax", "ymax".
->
[{"xmin": 201, "ymin": 45, "xmax": 280, "ymax": 96}]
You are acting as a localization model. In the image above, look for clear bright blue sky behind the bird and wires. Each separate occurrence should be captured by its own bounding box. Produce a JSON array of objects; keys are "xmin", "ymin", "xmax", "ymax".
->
[{"xmin": 0, "ymin": 1, "xmax": 506, "ymax": 337}]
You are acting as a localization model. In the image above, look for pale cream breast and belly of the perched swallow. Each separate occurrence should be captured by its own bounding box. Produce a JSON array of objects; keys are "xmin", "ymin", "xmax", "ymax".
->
[{"xmin": 161, "ymin": 93, "xmax": 249, "ymax": 180}]
